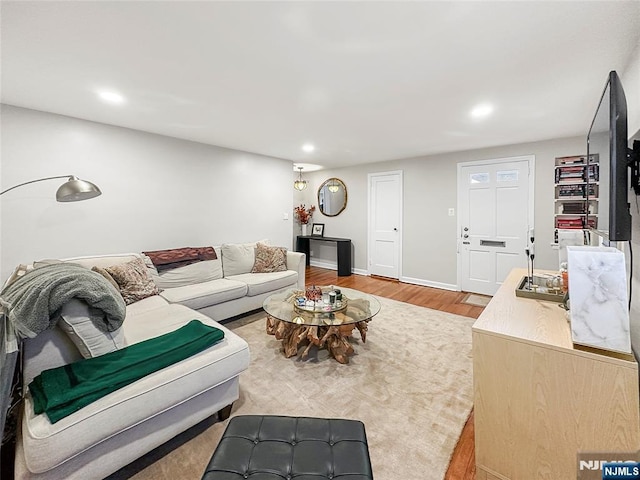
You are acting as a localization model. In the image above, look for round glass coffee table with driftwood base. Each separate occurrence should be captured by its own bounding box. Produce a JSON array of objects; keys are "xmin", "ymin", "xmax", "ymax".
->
[{"xmin": 262, "ymin": 287, "xmax": 380, "ymax": 363}]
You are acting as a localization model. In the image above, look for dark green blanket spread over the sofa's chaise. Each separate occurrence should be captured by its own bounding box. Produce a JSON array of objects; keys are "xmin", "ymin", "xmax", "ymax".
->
[{"xmin": 29, "ymin": 320, "xmax": 224, "ymax": 423}]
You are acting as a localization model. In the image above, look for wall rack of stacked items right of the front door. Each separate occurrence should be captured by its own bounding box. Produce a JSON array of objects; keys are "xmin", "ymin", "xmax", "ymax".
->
[{"xmin": 554, "ymin": 155, "xmax": 600, "ymax": 236}]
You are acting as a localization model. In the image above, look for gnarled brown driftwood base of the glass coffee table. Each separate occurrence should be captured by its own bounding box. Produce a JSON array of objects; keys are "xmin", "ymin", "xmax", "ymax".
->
[{"xmin": 267, "ymin": 315, "xmax": 369, "ymax": 364}]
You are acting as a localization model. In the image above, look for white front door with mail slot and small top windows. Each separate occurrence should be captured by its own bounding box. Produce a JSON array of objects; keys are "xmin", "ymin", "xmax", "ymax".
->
[{"xmin": 458, "ymin": 157, "xmax": 533, "ymax": 295}]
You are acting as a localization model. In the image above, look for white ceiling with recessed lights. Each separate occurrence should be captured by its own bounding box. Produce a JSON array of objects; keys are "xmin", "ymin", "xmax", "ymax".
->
[{"xmin": 0, "ymin": 1, "xmax": 640, "ymax": 167}]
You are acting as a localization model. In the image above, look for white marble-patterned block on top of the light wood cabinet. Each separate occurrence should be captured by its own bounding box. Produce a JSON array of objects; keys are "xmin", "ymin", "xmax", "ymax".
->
[{"xmin": 567, "ymin": 246, "xmax": 631, "ymax": 353}]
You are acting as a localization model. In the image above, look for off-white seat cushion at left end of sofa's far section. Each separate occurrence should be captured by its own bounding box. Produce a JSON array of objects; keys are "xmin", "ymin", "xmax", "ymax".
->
[{"xmin": 160, "ymin": 278, "xmax": 247, "ymax": 310}]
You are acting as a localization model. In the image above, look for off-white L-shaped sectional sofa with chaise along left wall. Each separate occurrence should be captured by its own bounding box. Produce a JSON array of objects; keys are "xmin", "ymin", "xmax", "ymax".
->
[{"xmin": 15, "ymin": 244, "xmax": 305, "ymax": 480}]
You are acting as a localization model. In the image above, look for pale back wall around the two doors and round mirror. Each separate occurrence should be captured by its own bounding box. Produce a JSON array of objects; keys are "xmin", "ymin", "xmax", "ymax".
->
[{"xmin": 304, "ymin": 135, "xmax": 588, "ymax": 288}]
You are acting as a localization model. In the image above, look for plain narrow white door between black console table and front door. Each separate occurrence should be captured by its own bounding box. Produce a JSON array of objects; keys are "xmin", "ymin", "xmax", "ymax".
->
[{"xmin": 369, "ymin": 172, "xmax": 402, "ymax": 278}]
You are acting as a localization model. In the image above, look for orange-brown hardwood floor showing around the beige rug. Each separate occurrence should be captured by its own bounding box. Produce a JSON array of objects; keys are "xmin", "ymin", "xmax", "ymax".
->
[{"xmin": 306, "ymin": 267, "xmax": 484, "ymax": 480}]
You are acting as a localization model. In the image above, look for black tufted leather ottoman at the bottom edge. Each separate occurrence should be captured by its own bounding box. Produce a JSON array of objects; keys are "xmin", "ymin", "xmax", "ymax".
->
[{"xmin": 202, "ymin": 415, "xmax": 373, "ymax": 480}]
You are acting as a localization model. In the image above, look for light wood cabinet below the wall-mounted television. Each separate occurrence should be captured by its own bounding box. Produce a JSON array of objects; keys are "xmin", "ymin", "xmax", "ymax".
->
[{"xmin": 472, "ymin": 269, "xmax": 640, "ymax": 480}]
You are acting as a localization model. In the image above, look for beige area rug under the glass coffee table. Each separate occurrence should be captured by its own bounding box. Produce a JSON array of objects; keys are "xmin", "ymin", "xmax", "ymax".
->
[{"xmin": 113, "ymin": 298, "xmax": 474, "ymax": 480}]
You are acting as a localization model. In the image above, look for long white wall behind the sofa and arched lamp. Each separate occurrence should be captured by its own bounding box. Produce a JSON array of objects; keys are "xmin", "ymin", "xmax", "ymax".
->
[{"xmin": 0, "ymin": 105, "xmax": 293, "ymax": 279}]
